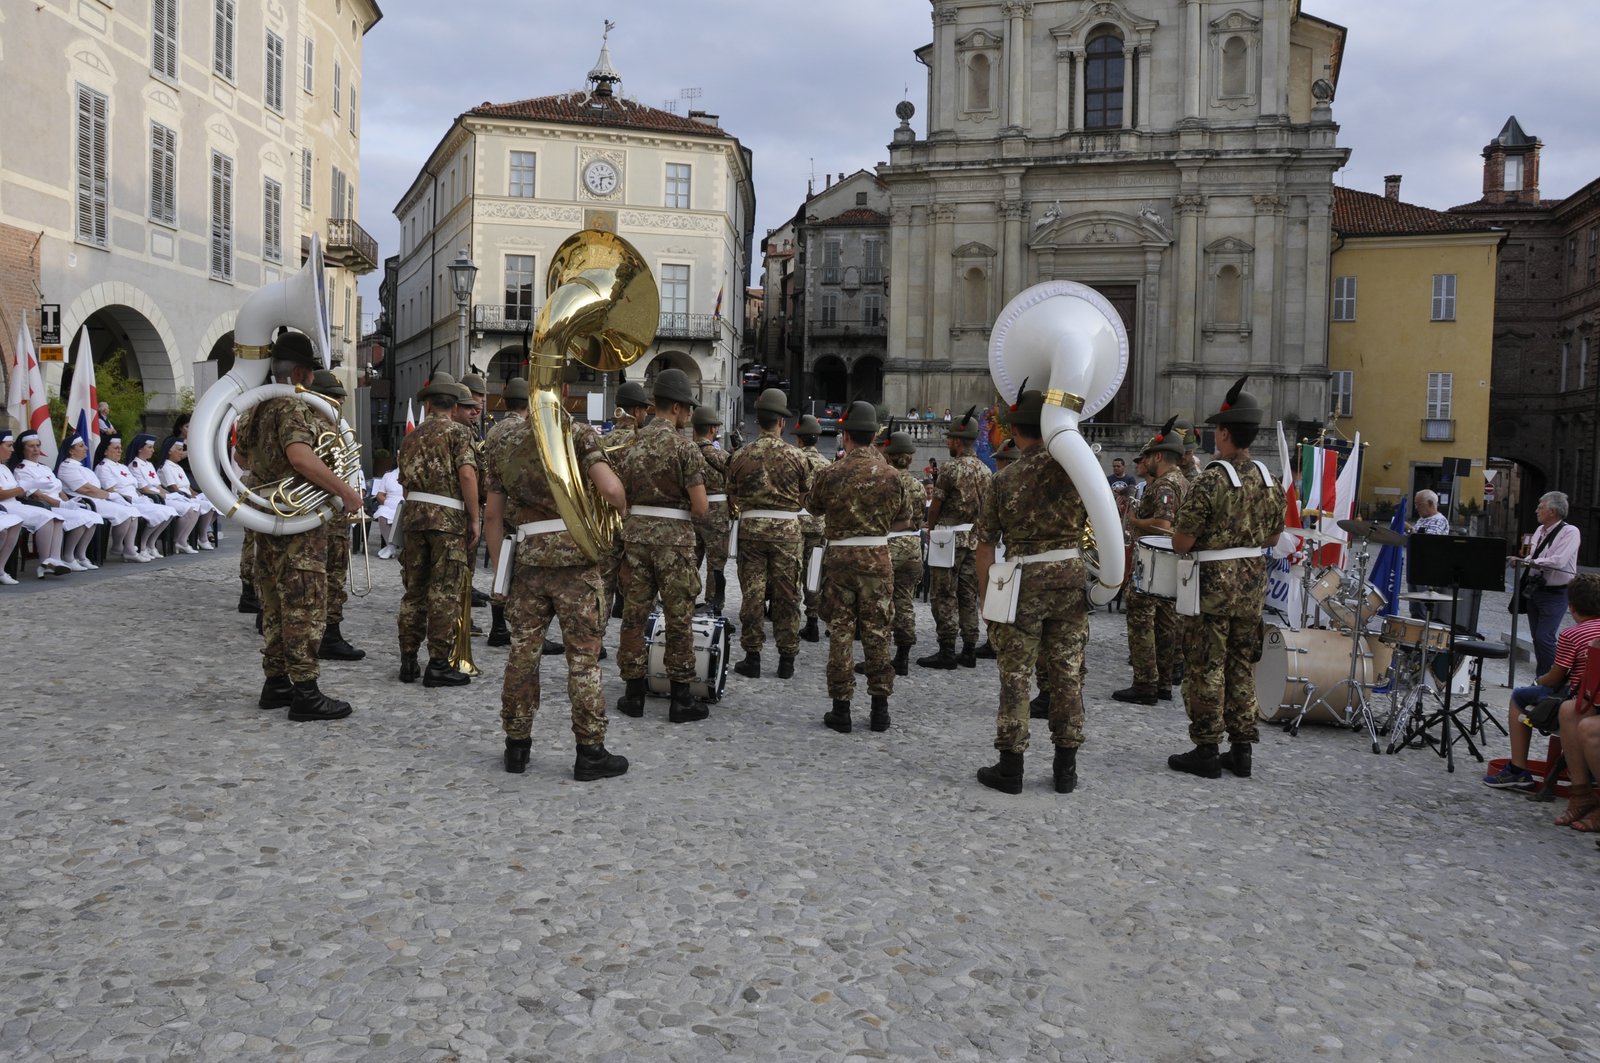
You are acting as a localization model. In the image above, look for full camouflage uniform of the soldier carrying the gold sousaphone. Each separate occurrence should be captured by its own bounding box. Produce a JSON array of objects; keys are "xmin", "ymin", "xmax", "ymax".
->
[{"xmin": 483, "ymin": 416, "xmax": 606, "ymax": 746}]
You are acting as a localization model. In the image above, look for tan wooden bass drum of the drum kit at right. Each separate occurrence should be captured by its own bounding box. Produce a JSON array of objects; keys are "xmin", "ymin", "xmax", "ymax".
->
[{"xmin": 1256, "ymin": 624, "xmax": 1394, "ymax": 724}]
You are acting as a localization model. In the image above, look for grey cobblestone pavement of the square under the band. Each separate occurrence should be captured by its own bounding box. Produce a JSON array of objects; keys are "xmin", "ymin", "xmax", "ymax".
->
[{"xmin": 0, "ymin": 540, "xmax": 1600, "ymax": 1063}]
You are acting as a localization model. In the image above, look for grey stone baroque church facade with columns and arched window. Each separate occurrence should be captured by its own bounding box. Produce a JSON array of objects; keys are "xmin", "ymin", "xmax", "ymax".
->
[{"xmin": 878, "ymin": 0, "xmax": 1349, "ymax": 445}]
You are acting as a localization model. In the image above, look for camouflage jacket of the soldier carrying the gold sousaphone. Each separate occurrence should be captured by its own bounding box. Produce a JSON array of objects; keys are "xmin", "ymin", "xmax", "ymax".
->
[{"xmin": 483, "ymin": 416, "xmax": 605, "ymax": 568}]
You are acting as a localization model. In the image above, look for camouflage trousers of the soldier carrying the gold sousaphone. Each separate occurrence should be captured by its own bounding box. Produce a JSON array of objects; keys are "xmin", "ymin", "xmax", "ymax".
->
[{"xmin": 501, "ymin": 560, "xmax": 605, "ymax": 746}]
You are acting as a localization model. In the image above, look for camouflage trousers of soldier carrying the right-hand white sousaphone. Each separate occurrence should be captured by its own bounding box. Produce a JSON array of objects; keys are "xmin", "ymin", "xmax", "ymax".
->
[{"xmin": 989, "ymin": 560, "xmax": 1090, "ymax": 752}]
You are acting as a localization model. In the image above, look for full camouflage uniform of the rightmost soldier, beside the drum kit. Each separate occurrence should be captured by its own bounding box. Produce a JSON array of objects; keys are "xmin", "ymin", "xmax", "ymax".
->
[{"xmin": 1173, "ymin": 455, "xmax": 1285, "ymax": 746}]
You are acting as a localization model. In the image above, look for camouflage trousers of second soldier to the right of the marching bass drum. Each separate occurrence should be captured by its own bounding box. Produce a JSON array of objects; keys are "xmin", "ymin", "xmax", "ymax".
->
[{"xmin": 818, "ymin": 546, "xmax": 894, "ymax": 701}]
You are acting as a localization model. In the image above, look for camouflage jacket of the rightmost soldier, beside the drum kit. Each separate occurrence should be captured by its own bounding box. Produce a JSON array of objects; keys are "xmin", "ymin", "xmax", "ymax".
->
[{"xmin": 1173, "ymin": 453, "xmax": 1285, "ymax": 616}]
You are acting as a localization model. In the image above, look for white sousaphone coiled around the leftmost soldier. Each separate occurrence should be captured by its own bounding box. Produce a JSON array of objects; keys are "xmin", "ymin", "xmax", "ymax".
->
[{"xmin": 189, "ymin": 234, "xmax": 360, "ymax": 535}]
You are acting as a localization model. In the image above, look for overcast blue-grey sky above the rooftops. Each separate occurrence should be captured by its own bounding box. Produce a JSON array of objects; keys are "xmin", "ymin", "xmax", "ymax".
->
[{"xmin": 350, "ymin": 0, "xmax": 1600, "ymax": 317}]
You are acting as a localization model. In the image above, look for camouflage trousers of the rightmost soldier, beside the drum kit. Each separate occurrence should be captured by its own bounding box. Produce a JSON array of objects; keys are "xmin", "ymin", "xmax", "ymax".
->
[{"xmin": 1182, "ymin": 613, "xmax": 1262, "ymax": 746}]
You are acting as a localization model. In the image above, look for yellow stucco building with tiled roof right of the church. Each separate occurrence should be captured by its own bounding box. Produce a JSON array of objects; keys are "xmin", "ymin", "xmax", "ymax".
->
[{"xmin": 1328, "ymin": 185, "xmax": 1506, "ymax": 517}]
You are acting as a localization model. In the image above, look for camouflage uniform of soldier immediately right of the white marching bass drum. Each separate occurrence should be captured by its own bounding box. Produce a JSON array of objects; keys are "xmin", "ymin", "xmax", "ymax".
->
[{"xmin": 728, "ymin": 435, "xmax": 814, "ymax": 656}]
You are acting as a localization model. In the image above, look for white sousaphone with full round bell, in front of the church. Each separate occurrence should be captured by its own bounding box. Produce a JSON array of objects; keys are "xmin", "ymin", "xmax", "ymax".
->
[{"xmin": 989, "ymin": 280, "xmax": 1128, "ymax": 605}]
